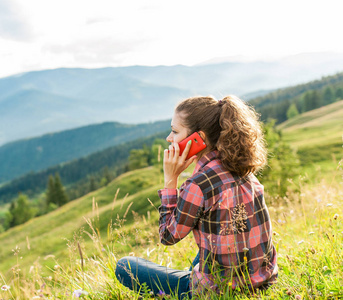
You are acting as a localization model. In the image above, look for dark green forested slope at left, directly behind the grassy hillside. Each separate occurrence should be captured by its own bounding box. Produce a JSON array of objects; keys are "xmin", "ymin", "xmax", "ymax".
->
[{"xmin": 0, "ymin": 131, "xmax": 168, "ymax": 204}]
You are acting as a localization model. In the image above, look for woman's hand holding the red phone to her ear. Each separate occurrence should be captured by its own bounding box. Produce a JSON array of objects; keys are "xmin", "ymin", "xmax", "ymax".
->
[{"xmin": 163, "ymin": 141, "xmax": 196, "ymax": 189}]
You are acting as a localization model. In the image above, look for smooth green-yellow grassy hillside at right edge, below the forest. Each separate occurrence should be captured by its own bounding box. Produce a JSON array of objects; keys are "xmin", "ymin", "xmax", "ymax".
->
[{"xmin": 278, "ymin": 100, "xmax": 343, "ymax": 177}]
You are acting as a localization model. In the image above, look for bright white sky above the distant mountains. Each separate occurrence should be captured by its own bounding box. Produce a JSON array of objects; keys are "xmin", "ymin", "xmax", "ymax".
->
[{"xmin": 0, "ymin": 0, "xmax": 343, "ymax": 77}]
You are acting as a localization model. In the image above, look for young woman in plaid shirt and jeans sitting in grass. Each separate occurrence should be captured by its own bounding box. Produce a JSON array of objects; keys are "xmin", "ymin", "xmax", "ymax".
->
[{"xmin": 116, "ymin": 96, "xmax": 278, "ymax": 299}]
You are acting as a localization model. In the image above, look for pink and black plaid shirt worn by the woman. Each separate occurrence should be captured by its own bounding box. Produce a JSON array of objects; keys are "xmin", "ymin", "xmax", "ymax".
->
[{"xmin": 158, "ymin": 151, "xmax": 278, "ymax": 292}]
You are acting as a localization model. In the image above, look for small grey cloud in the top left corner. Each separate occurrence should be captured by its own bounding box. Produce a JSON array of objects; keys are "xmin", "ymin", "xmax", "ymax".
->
[{"xmin": 0, "ymin": 0, "xmax": 31, "ymax": 41}]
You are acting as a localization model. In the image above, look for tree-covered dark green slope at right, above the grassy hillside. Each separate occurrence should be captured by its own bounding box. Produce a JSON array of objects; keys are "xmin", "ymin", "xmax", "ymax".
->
[{"xmin": 249, "ymin": 73, "xmax": 343, "ymax": 123}]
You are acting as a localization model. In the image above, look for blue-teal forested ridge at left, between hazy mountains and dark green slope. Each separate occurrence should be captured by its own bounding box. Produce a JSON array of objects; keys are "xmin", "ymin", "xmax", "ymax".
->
[{"xmin": 0, "ymin": 120, "xmax": 170, "ymax": 183}]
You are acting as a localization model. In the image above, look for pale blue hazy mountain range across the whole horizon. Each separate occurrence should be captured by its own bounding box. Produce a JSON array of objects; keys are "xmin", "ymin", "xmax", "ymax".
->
[{"xmin": 0, "ymin": 53, "xmax": 343, "ymax": 146}]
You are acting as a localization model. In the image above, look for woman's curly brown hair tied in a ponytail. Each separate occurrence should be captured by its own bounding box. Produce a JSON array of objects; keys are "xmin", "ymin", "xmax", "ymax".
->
[{"xmin": 175, "ymin": 96, "xmax": 267, "ymax": 177}]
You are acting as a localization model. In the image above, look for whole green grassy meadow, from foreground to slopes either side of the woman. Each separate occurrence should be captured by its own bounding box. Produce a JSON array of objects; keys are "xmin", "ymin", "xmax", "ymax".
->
[{"xmin": 0, "ymin": 101, "xmax": 343, "ymax": 299}]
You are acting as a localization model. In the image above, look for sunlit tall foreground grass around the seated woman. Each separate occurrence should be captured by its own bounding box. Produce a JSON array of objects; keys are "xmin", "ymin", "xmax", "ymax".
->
[{"xmin": 0, "ymin": 163, "xmax": 343, "ymax": 300}]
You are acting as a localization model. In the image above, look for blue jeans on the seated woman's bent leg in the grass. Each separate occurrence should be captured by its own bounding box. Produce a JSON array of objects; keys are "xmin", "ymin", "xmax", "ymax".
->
[{"xmin": 115, "ymin": 253, "xmax": 199, "ymax": 299}]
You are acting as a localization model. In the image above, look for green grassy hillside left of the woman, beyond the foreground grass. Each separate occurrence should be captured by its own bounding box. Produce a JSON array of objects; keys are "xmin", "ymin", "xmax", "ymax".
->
[{"xmin": 0, "ymin": 168, "xmax": 165, "ymax": 274}]
